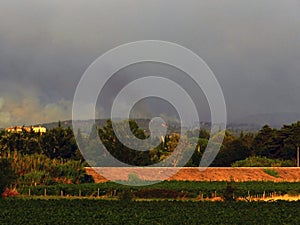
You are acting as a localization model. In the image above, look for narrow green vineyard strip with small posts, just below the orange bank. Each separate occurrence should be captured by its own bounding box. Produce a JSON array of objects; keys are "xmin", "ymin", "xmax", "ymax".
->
[{"xmin": 18, "ymin": 181, "xmax": 300, "ymax": 198}]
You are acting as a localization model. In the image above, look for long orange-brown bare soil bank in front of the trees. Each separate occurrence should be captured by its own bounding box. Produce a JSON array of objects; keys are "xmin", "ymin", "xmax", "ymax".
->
[{"xmin": 86, "ymin": 167, "xmax": 300, "ymax": 183}]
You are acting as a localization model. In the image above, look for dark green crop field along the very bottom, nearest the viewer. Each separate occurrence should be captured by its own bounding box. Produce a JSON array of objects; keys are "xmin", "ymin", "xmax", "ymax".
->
[{"xmin": 0, "ymin": 198, "xmax": 300, "ymax": 224}]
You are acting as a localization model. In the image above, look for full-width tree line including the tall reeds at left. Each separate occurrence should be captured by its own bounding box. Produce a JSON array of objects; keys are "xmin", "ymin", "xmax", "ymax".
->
[{"xmin": 0, "ymin": 120, "xmax": 300, "ymax": 194}]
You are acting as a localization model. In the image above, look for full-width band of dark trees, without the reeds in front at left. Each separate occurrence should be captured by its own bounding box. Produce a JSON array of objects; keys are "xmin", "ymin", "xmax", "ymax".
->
[{"xmin": 0, "ymin": 120, "xmax": 300, "ymax": 166}]
